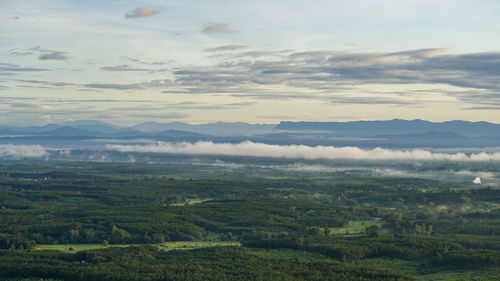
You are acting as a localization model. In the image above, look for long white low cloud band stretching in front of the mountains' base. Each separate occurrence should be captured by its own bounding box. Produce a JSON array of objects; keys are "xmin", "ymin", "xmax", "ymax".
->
[{"xmin": 106, "ymin": 141, "xmax": 500, "ymax": 161}]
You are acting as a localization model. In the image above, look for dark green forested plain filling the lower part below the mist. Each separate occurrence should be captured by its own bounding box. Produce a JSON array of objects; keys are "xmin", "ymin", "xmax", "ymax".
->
[{"xmin": 0, "ymin": 161, "xmax": 500, "ymax": 280}]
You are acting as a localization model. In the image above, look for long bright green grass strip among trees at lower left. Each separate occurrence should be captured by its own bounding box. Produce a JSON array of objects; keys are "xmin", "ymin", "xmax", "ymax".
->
[{"xmin": 35, "ymin": 241, "xmax": 240, "ymax": 253}]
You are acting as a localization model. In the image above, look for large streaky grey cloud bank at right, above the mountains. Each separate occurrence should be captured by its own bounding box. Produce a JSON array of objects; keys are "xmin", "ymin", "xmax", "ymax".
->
[{"xmin": 166, "ymin": 48, "xmax": 500, "ymax": 105}]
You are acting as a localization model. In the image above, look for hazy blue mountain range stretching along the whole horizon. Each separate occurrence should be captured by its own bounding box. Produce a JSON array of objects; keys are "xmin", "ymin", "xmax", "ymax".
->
[{"xmin": 0, "ymin": 119, "xmax": 500, "ymax": 148}]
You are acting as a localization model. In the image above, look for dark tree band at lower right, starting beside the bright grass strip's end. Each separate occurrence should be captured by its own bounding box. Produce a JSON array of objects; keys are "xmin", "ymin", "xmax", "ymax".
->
[{"xmin": 241, "ymin": 233, "xmax": 500, "ymax": 270}]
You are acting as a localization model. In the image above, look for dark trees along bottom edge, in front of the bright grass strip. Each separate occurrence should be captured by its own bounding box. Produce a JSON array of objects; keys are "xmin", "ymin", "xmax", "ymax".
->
[{"xmin": 0, "ymin": 246, "xmax": 413, "ymax": 281}]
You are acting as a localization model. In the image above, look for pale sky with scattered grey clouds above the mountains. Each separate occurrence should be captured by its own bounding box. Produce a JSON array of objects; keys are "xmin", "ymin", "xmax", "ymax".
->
[{"xmin": 0, "ymin": 0, "xmax": 500, "ymax": 126}]
